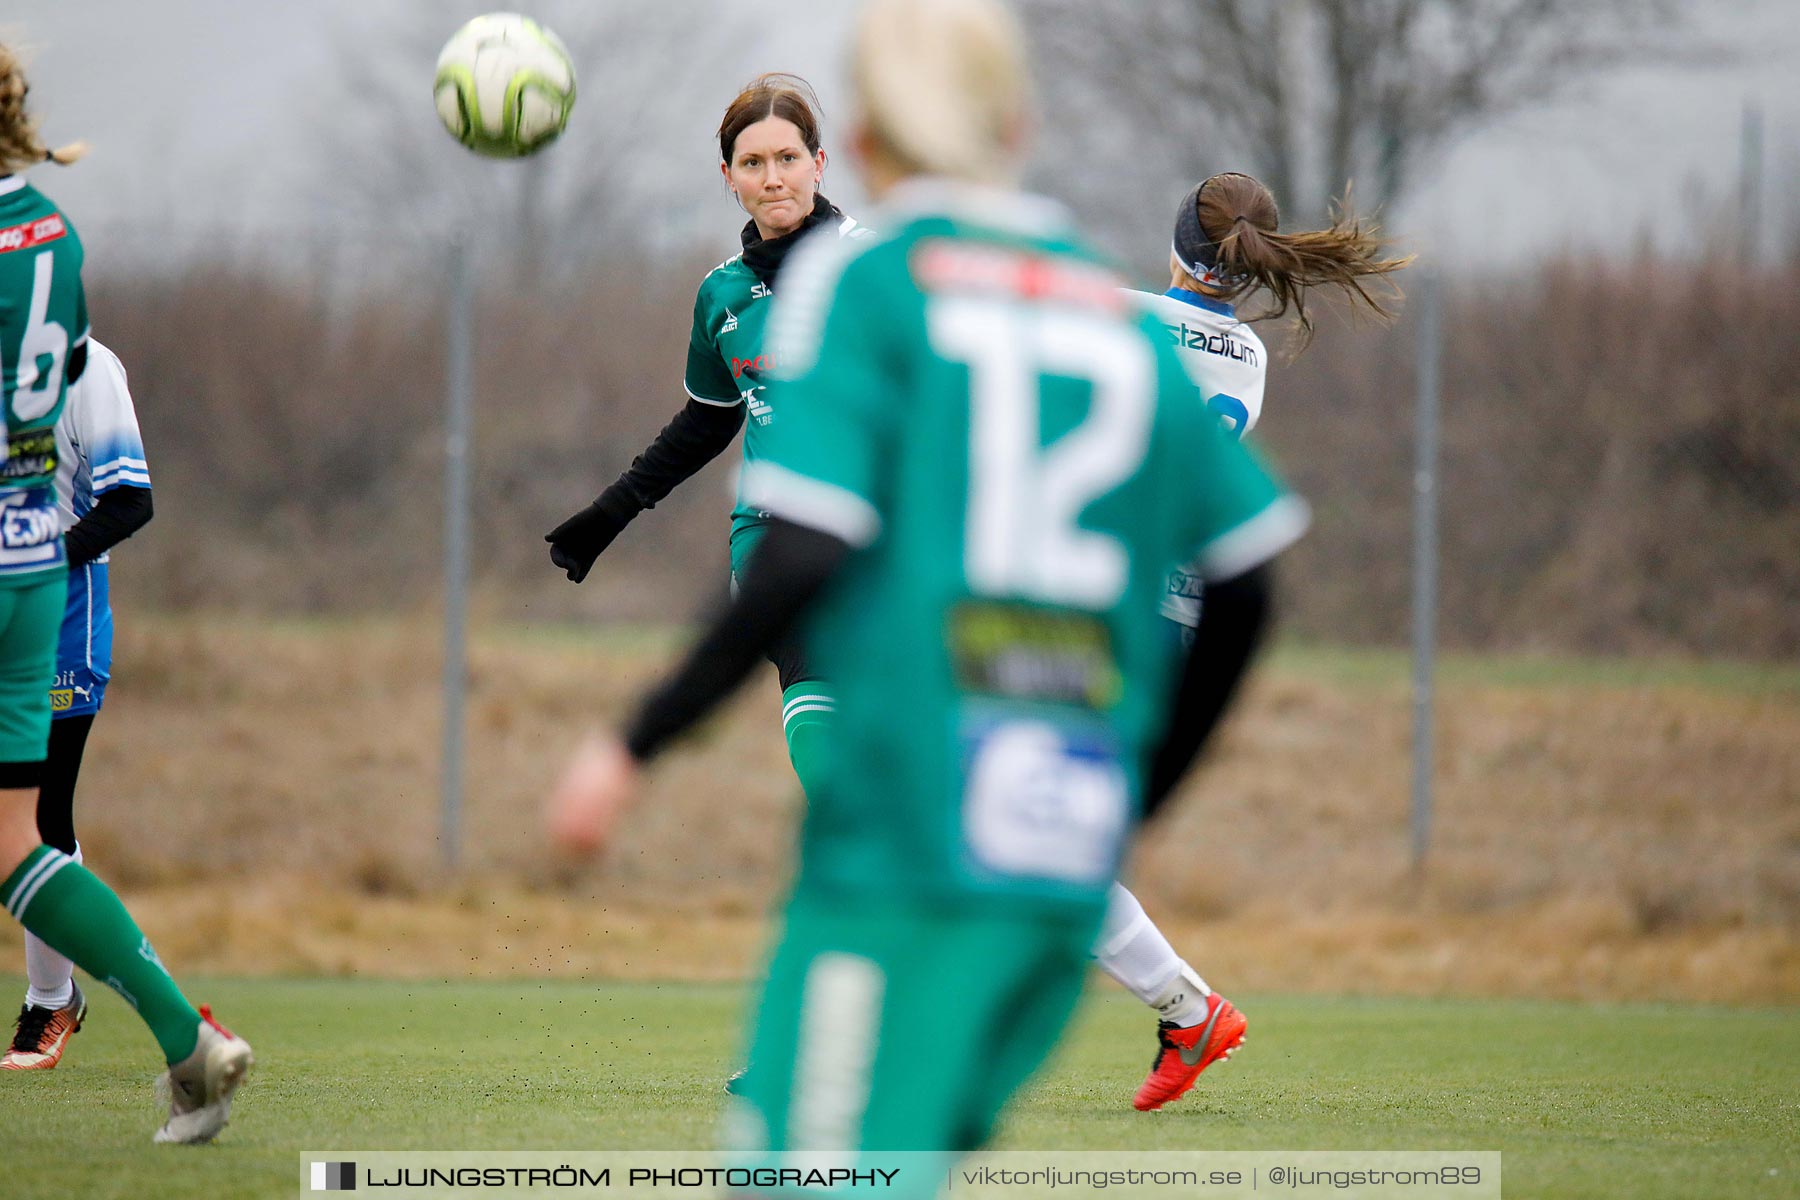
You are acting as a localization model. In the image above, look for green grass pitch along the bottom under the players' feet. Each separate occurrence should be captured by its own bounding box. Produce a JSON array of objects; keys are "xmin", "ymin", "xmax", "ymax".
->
[{"xmin": 0, "ymin": 975, "xmax": 1800, "ymax": 1200}]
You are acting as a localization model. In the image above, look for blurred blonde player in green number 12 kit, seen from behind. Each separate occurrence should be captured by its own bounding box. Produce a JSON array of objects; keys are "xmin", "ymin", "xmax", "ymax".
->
[{"xmin": 551, "ymin": 0, "xmax": 1305, "ymax": 1195}]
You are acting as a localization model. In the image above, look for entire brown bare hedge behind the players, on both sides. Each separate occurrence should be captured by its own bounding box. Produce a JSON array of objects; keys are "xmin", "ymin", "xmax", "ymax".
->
[{"xmin": 94, "ymin": 252, "xmax": 1800, "ymax": 660}]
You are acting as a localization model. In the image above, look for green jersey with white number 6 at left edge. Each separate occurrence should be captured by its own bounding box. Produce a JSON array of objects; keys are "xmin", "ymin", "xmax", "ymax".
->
[{"xmin": 0, "ymin": 175, "xmax": 88, "ymax": 587}]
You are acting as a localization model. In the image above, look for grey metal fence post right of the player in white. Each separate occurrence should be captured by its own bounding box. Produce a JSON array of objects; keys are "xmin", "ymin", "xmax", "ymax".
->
[{"xmin": 1411, "ymin": 273, "xmax": 1444, "ymax": 873}]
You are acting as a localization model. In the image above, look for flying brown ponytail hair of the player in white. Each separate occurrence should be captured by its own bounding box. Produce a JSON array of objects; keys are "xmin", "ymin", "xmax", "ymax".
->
[{"xmin": 1193, "ymin": 171, "xmax": 1413, "ymax": 345}]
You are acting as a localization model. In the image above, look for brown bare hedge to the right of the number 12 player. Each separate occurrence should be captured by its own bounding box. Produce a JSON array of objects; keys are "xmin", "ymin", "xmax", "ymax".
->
[{"xmin": 1260, "ymin": 261, "xmax": 1800, "ymax": 657}]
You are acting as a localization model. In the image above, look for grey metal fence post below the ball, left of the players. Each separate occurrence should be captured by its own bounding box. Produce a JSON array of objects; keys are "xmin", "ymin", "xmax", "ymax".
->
[{"xmin": 439, "ymin": 234, "xmax": 475, "ymax": 869}]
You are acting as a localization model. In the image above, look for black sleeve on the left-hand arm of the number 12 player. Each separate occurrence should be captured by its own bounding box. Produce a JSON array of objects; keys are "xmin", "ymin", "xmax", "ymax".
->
[{"xmin": 625, "ymin": 518, "xmax": 850, "ymax": 763}]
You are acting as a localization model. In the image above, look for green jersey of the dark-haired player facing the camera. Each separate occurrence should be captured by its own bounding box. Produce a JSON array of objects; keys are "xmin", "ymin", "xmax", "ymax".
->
[{"xmin": 684, "ymin": 218, "xmax": 868, "ymax": 540}]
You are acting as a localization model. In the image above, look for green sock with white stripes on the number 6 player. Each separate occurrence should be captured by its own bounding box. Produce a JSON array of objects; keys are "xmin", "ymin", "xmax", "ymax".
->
[{"xmin": 0, "ymin": 846, "xmax": 200, "ymax": 1063}]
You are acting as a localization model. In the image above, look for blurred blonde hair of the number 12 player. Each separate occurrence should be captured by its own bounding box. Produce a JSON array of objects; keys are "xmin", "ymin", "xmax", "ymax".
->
[{"xmin": 853, "ymin": 0, "xmax": 1031, "ymax": 184}]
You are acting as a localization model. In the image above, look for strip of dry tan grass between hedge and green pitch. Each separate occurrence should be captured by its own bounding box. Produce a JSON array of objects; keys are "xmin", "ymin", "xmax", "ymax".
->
[{"xmin": 0, "ymin": 610, "xmax": 1800, "ymax": 1002}]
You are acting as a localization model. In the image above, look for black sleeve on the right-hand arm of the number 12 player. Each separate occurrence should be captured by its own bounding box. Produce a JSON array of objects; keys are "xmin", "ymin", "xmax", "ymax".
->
[{"xmin": 1143, "ymin": 563, "xmax": 1274, "ymax": 819}]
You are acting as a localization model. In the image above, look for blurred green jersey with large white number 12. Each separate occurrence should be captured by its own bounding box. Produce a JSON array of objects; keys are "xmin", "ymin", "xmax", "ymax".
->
[{"xmin": 742, "ymin": 185, "xmax": 1305, "ymax": 910}]
